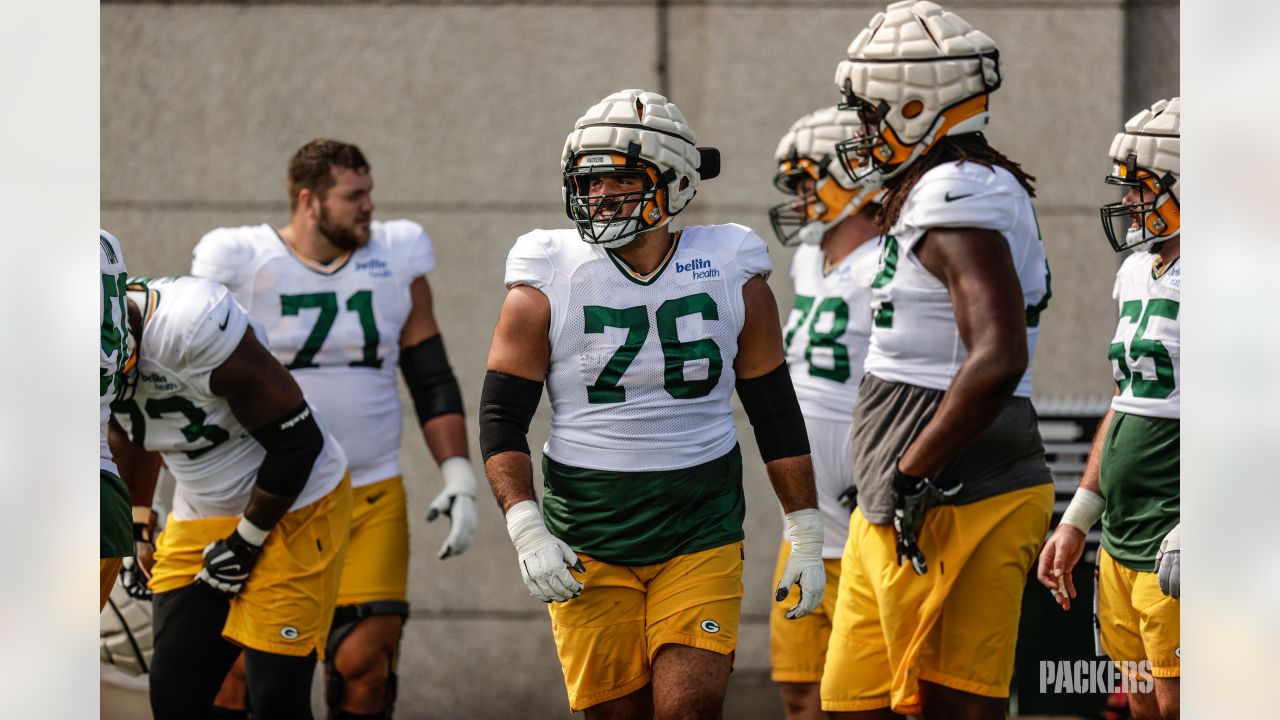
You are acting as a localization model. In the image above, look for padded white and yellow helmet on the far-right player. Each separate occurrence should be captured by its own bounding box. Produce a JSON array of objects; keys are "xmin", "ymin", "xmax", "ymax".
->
[{"xmin": 1102, "ymin": 97, "xmax": 1183, "ymax": 252}]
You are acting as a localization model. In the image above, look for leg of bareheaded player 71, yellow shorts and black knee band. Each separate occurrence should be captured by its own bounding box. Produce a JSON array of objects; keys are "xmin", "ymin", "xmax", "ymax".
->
[{"xmin": 325, "ymin": 475, "xmax": 408, "ymax": 717}]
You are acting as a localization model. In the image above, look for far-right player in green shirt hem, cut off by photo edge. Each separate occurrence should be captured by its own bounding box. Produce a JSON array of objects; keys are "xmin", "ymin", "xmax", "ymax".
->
[{"xmin": 1037, "ymin": 97, "xmax": 1183, "ymax": 719}]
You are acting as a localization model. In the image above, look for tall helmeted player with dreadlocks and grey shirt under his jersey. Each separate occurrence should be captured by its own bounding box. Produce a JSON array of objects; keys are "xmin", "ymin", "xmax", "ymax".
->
[{"xmin": 822, "ymin": 1, "xmax": 1053, "ymax": 717}]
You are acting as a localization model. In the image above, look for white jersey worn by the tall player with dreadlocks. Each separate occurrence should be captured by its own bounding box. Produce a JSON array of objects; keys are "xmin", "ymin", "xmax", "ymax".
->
[{"xmin": 867, "ymin": 163, "xmax": 1050, "ymax": 397}]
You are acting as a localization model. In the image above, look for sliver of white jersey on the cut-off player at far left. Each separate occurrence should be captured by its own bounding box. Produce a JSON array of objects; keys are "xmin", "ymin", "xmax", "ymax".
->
[{"xmin": 97, "ymin": 231, "xmax": 129, "ymax": 475}]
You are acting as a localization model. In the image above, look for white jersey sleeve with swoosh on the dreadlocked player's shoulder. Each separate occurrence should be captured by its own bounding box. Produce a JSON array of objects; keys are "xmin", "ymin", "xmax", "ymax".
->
[{"xmin": 900, "ymin": 168, "xmax": 1019, "ymax": 245}]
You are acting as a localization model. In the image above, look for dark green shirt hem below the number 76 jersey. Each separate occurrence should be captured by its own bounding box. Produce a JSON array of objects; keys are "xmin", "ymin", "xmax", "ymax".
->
[{"xmin": 543, "ymin": 445, "xmax": 746, "ymax": 565}]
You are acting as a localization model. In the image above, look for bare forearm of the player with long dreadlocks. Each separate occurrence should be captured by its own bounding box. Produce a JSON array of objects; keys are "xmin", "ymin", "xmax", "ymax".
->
[{"xmin": 899, "ymin": 340, "xmax": 1025, "ymax": 478}]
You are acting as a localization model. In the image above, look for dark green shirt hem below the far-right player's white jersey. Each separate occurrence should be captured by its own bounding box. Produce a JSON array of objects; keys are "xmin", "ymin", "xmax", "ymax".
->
[{"xmin": 1098, "ymin": 413, "xmax": 1180, "ymax": 573}]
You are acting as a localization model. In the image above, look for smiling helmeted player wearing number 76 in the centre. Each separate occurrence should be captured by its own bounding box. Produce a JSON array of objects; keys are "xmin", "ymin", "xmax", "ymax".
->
[{"xmin": 480, "ymin": 90, "xmax": 826, "ymax": 719}]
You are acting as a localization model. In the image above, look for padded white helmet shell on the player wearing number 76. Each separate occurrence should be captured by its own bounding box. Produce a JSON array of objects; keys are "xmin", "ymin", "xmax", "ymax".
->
[{"xmin": 561, "ymin": 90, "xmax": 701, "ymax": 213}]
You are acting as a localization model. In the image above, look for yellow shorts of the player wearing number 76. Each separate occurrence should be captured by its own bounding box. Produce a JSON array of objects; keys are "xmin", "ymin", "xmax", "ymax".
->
[{"xmin": 548, "ymin": 542, "xmax": 742, "ymax": 712}]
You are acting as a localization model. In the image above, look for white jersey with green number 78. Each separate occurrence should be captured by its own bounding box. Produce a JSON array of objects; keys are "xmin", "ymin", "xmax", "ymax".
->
[{"xmin": 783, "ymin": 240, "xmax": 879, "ymax": 420}]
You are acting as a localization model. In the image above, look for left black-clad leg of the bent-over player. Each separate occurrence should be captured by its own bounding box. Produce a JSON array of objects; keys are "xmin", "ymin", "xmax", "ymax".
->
[{"xmin": 150, "ymin": 583, "xmax": 239, "ymax": 720}]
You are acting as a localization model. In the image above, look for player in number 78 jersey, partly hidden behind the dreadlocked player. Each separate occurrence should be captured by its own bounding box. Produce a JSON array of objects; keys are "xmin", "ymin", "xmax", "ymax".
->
[{"xmin": 769, "ymin": 108, "xmax": 881, "ymax": 720}]
